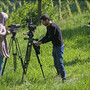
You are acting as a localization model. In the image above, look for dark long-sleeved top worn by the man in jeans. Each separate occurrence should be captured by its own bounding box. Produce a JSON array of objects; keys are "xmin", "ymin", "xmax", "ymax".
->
[{"xmin": 40, "ymin": 23, "xmax": 63, "ymax": 46}]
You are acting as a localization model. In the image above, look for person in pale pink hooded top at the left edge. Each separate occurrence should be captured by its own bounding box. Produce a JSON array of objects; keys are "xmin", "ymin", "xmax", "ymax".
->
[{"xmin": 0, "ymin": 12, "xmax": 10, "ymax": 75}]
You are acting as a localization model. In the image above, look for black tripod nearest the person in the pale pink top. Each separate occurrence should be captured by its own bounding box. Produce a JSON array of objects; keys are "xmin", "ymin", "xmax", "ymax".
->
[{"xmin": 1, "ymin": 32, "xmax": 24, "ymax": 75}]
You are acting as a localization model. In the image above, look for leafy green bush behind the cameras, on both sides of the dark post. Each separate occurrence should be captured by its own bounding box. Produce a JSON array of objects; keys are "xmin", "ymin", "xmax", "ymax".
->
[{"xmin": 8, "ymin": 0, "xmax": 55, "ymax": 27}]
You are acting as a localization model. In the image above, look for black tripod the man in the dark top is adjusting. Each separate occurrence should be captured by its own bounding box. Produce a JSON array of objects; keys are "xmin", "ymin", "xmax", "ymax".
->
[{"xmin": 22, "ymin": 36, "xmax": 45, "ymax": 80}]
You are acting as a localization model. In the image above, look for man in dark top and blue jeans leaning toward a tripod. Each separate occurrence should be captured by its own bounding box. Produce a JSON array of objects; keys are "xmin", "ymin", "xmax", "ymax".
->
[{"xmin": 34, "ymin": 14, "xmax": 66, "ymax": 82}]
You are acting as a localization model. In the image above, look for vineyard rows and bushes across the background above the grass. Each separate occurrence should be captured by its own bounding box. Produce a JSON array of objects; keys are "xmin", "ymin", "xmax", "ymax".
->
[{"xmin": 0, "ymin": 0, "xmax": 90, "ymax": 26}]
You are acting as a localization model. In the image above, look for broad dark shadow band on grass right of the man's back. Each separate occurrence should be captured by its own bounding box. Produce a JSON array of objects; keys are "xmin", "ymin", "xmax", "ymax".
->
[{"xmin": 62, "ymin": 26, "xmax": 90, "ymax": 40}]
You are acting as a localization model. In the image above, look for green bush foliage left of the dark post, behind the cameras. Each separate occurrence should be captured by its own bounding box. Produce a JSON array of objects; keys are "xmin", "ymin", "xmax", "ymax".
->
[{"xmin": 5, "ymin": 2, "xmax": 37, "ymax": 26}]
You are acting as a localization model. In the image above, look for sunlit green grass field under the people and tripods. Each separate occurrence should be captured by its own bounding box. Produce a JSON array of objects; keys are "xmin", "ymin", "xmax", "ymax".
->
[{"xmin": 0, "ymin": 15, "xmax": 90, "ymax": 90}]
